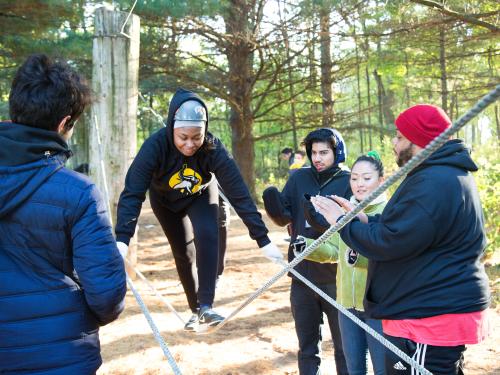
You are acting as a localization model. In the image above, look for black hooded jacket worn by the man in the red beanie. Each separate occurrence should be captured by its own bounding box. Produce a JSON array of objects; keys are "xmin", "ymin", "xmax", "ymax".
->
[{"xmin": 340, "ymin": 140, "xmax": 490, "ymax": 319}]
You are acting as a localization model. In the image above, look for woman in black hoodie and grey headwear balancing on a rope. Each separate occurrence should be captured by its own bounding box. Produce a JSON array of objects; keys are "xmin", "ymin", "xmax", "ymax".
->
[{"xmin": 115, "ymin": 89, "xmax": 282, "ymax": 331}]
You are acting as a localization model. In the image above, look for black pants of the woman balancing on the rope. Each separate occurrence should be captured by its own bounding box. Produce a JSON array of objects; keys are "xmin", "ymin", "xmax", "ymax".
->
[{"xmin": 150, "ymin": 183, "xmax": 219, "ymax": 312}]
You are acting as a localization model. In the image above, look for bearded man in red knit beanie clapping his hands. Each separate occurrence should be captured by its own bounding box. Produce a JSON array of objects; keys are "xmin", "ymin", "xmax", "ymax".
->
[{"xmin": 314, "ymin": 104, "xmax": 490, "ymax": 375}]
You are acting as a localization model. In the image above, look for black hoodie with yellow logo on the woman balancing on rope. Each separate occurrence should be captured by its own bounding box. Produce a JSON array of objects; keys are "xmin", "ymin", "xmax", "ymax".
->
[{"xmin": 115, "ymin": 89, "xmax": 271, "ymax": 247}]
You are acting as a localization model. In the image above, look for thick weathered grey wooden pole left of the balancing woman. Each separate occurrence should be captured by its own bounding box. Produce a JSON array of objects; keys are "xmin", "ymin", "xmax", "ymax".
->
[{"xmin": 90, "ymin": 7, "xmax": 140, "ymax": 276}]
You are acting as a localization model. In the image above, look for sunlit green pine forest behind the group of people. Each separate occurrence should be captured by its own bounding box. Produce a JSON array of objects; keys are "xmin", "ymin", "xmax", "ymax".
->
[{"xmin": 0, "ymin": 0, "xmax": 500, "ymax": 264}]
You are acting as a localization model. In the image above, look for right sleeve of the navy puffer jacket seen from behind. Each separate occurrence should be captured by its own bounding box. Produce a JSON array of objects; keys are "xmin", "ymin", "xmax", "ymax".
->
[{"xmin": 71, "ymin": 185, "xmax": 127, "ymax": 325}]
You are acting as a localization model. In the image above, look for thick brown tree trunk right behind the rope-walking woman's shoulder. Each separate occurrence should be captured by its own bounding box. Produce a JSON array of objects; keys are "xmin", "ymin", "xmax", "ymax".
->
[{"xmin": 224, "ymin": 0, "xmax": 255, "ymax": 198}]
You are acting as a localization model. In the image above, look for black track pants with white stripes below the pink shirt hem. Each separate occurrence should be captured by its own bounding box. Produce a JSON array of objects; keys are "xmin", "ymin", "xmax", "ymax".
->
[{"xmin": 385, "ymin": 335, "xmax": 465, "ymax": 375}]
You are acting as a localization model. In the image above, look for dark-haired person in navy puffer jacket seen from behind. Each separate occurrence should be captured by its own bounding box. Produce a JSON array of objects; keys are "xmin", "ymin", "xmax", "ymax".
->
[{"xmin": 0, "ymin": 55, "xmax": 126, "ymax": 375}]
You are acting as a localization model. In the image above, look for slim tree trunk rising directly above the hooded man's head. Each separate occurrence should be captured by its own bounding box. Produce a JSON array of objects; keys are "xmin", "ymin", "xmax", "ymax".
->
[{"xmin": 320, "ymin": 5, "xmax": 334, "ymax": 128}]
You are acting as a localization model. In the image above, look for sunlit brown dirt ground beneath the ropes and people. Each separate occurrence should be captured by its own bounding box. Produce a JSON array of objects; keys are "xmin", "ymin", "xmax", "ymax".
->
[{"xmin": 98, "ymin": 206, "xmax": 500, "ymax": 375}]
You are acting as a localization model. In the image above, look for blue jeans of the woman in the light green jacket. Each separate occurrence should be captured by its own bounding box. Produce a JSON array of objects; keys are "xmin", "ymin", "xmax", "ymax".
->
[{"xmin": 339, "ymin": 309, "xmax": 385, "ymax": 375}]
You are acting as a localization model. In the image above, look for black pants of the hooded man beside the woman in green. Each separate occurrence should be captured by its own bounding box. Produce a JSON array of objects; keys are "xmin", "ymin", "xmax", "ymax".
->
[{"xmin": 290, "ymin": 279, "xmax": 348, "ymax": 375}]
